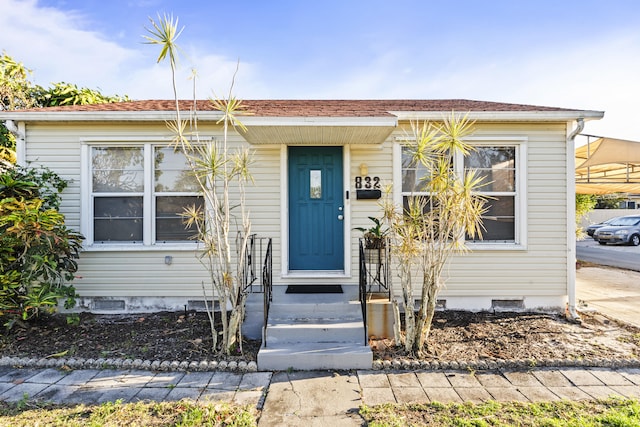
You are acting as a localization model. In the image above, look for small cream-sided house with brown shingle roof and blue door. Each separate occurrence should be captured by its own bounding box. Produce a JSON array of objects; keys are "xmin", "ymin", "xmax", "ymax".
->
[{"xmin": 0, "ymin": 100, "xmax": 603, "ymax": 370}]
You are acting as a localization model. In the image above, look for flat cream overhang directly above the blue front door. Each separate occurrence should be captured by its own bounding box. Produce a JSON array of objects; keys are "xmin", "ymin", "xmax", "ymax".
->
[{"xmin": 241, "ymin": 116, "xmax": 398, "ymax": 145}]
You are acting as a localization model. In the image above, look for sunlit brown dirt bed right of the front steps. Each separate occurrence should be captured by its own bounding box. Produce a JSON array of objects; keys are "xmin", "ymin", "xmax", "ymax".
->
[{"xmin": 371, "ymin": 312, "xmax": 640, "ymax": 362}]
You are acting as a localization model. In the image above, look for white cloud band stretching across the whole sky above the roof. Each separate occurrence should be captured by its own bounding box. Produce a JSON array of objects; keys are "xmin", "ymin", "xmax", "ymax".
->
[{"xmin": 0, "ymin": 0, "xmax": 640, "ymax": 140}]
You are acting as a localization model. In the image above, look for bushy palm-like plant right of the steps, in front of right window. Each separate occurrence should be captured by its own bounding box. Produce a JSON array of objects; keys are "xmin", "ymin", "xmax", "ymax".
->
[{"xmin": 383, "ymin": 113, "xmax": 487, "ymax": 355}]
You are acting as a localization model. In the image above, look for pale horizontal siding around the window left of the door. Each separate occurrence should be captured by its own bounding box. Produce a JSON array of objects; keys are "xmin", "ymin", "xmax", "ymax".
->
[{"xmin": 26, "ymin": 123, "xmax": 242, "ymax": 298}]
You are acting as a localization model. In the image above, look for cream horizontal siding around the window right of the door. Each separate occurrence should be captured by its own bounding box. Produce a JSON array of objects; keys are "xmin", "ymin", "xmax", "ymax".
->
[{"xmin": 384, "ymin": 124, "xmax": 568, "ymax": 308}]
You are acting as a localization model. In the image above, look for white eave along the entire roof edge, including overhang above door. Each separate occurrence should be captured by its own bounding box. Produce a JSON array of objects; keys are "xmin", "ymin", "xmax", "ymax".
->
[{"xmin": 0, "ymin": 106, "xmax": 604, "ymax": 145}]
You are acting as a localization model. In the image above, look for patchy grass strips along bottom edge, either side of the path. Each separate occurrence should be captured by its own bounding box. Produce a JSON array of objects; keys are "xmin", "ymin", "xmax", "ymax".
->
[{"xmin": 0, "ymin": 399, "xmax": 640, "ymax": 427}]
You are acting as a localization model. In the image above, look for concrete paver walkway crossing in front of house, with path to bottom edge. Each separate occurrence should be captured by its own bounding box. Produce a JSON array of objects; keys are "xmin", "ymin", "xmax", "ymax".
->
[{"xmin": 0, "ymin": 367, "xmax": 640, "ymax": 427}]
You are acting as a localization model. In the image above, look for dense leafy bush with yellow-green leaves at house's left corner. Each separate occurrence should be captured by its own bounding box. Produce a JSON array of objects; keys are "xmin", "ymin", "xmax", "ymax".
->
[{"xmin": 0, "ymin": 166, "xmax": 83, "ymax": 327}]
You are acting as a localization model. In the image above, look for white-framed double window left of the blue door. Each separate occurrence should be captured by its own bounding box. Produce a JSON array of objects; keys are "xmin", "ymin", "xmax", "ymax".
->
[{"xmin": 89, "ymin": 144, "xmax": 203, "ymax": 245}]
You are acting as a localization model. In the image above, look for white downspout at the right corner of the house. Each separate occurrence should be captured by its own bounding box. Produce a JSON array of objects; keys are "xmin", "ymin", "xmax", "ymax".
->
[{"xmin": 565, "ymin": 118, "xmax": 584, "ymax": 322}]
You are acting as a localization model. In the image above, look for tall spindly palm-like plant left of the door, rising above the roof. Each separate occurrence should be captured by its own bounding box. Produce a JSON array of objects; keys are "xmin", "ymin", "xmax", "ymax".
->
[{"xmin": 146, "ymin": 15, "xmax": 252, "ymax": 354}]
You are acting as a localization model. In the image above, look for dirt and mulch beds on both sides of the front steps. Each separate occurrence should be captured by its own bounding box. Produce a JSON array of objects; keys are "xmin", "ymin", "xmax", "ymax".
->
[{"xmin": 0, "ymin": 311, "xmax": 640, "ymax": 362}]
